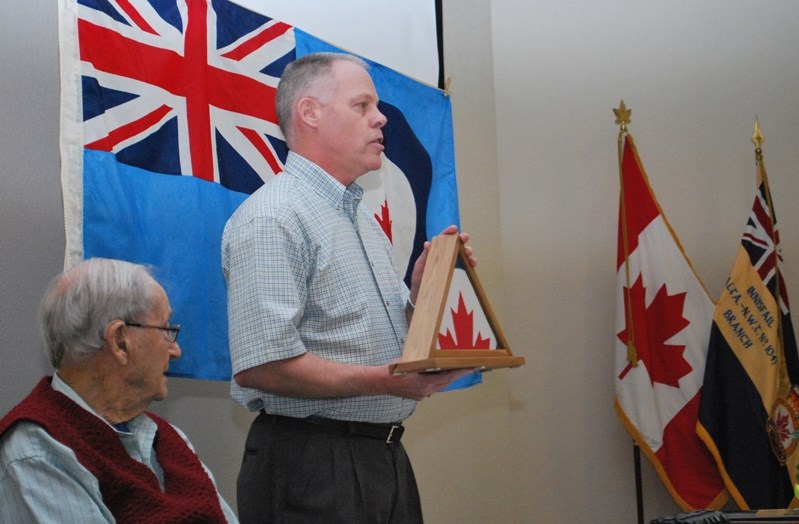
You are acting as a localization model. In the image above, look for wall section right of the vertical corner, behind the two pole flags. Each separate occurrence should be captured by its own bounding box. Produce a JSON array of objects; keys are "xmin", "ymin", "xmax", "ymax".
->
[{"xmin": 491, "ymin": 0, "xmax": 799, "ymax": 522}]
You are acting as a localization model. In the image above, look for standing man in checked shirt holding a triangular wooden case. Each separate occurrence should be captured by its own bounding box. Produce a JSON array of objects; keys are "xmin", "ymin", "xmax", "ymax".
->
[{"xmin": 222, "ymin": 53, "xmax": 474, "ymax": 524}]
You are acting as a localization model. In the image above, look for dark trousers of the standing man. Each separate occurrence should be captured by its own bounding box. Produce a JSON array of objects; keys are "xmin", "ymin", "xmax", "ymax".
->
[{"xmin": 237, "ymin": 412, "xmax": 422, "ymax": 524}]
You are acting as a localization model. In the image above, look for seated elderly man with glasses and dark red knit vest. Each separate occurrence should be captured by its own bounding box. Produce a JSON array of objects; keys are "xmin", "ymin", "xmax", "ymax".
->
[{"xmin": 0, "ymin": 259, "xmax": 236, "ymax": 523}]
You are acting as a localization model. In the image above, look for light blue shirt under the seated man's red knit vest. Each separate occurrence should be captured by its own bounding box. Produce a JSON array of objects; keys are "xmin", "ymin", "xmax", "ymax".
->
[{"xmin": 0, "ymin": 373, "xmax": 238, "ymax": 523}]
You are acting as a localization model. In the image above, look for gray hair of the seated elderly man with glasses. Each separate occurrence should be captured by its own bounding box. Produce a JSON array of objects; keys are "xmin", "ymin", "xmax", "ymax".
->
[{"xmin": 39, "ymin": 258, "xmax": 157, "ymax": 369}]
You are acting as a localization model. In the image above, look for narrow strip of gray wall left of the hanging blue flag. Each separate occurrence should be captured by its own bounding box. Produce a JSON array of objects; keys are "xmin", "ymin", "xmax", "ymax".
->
[{"xmin": 0, "ymin": 5, "xmax": 64, "ymax": 402}]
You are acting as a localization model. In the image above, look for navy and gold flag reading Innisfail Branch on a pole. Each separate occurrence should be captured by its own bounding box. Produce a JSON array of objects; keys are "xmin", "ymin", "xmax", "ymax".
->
[{"xmin": 697, "ymin": 133, "xmax": 799, "ymax": 509}]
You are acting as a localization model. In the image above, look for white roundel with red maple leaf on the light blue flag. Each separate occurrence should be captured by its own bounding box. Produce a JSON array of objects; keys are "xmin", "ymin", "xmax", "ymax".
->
[{"xmin": 358, "ymin": 154, "xmax": 416, "ymax": 276}]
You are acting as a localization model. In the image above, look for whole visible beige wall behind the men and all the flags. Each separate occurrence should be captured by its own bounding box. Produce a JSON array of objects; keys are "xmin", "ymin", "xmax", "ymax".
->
[{"xmin": 0, "ymin": 0, "xmax": 799, "ymax": 524}]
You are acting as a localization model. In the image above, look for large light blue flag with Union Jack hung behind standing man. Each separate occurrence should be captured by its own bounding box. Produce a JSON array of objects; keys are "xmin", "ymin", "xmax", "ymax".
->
[{"xmin": 59, "ymin": 0, "xmax": 479, "ymax": 381}]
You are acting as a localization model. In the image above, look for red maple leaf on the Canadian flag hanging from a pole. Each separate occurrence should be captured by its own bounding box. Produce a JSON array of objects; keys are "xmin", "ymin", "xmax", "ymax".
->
[{"xmin": 617, "ymin": 275, "xmax": 693, "ymax": 388}]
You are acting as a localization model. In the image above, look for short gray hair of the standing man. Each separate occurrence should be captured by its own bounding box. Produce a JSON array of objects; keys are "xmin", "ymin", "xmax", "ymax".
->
[{"xmin": 275, "ymin": 52, "xmax": 369, "ymax": 142}]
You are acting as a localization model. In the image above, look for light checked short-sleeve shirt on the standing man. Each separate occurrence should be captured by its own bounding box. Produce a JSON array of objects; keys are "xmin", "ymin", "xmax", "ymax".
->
[{"xmin": 222, "ymin": 153, "xmax": 416, "ymax": 422}]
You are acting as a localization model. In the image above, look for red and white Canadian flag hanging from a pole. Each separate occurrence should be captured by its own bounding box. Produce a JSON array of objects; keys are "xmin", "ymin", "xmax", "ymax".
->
[{"xmin": 615, "ymin": 135, "xmax": 727, "ymax": 511}]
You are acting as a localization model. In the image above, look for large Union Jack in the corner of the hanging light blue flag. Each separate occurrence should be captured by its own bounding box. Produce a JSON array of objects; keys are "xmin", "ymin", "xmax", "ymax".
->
[{"xmin": 77, "ymin": 0, "xmax": 294, "ymax": 193}]
